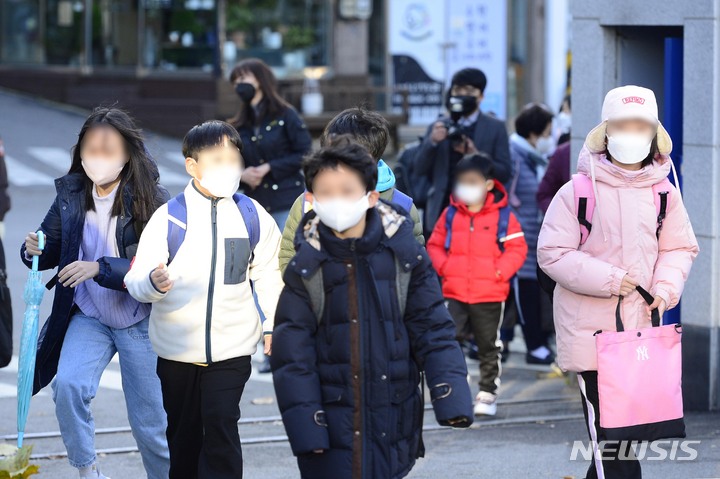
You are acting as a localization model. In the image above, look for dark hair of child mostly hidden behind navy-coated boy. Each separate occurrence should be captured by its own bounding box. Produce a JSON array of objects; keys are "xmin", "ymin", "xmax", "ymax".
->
[{"xmin": 320, "ymin": 106, "xmax": 390, "ymax": 161}]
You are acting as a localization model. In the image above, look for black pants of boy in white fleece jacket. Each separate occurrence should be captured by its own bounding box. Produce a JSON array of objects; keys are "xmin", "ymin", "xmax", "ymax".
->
[{"xmin": 157, "ymin": 356, "xmax": 252, "ymax": 479}]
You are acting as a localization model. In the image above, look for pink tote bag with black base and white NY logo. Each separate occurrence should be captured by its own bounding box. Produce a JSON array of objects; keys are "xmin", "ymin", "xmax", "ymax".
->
[{"xmin": 595, "ymin": 286, "xmax": 685, "ymax": 441}]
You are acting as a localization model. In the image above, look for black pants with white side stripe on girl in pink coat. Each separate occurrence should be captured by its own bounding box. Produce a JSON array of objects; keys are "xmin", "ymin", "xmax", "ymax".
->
[{"xmin": 578, "ymin": 371, "xmax": 642, "ymax": 479}]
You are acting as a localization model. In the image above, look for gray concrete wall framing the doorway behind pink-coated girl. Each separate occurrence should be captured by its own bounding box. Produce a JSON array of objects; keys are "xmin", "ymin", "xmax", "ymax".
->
[{"xmin": 571, "ymin": 0, "xmax": 720, "ymax": 409}]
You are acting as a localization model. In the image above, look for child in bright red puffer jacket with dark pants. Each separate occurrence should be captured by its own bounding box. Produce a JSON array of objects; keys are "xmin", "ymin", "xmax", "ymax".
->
[{"xmin": 427, "ymin": 153, "xmax": 527, "ymax": 416}]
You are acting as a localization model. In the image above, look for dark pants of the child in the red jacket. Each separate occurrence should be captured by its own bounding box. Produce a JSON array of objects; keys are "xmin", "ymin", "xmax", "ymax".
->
[{"xmin": 448, "ymin": 299, "xmax": 503, "ymax": 393}]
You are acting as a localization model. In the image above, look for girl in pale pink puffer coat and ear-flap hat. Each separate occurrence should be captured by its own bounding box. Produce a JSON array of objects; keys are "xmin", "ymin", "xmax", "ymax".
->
[{"xmin": 538, "ymin": 86, "xmax": 698, "ymax": 479}]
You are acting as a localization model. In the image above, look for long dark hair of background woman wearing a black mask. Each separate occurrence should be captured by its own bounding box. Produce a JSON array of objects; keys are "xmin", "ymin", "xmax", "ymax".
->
[{"xmin": 228, "ymin": 58, "xmax": 290, "ymax": 128}]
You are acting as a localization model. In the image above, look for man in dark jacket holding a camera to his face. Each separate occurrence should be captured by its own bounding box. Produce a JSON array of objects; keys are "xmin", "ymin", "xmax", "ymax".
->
[{"xmin": 415, "ymin": 68, "xmax": 512, "ymax": 237}]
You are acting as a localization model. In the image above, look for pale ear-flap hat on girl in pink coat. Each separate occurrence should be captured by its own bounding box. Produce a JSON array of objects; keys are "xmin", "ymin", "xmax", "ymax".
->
[{"xmin": 585, "ymin": 85, "xmax": 672, "ymax": 155}]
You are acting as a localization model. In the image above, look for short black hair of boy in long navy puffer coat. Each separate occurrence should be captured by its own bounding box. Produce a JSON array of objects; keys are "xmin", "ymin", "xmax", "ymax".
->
[{"xmin": 303, "ymin": 135, "xmax": 378, "ymax": 193}]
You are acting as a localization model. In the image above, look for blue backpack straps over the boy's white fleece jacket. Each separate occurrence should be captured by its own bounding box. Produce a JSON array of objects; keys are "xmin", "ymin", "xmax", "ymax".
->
[{"xmin": 167, "ymin": 193, "xmax": 260, "ymax": 264}]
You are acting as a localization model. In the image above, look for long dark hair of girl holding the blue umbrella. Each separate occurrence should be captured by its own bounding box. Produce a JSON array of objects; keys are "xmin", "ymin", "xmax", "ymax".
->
[{"xmin": 69, "ymin": 107, "xmax": 160, "ymax": 223}]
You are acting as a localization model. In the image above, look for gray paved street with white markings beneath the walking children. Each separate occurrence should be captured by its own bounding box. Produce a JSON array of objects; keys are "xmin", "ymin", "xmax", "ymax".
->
[{"xmin": 0, "ymin": 91, "xmax": 720, "ymax": 479}]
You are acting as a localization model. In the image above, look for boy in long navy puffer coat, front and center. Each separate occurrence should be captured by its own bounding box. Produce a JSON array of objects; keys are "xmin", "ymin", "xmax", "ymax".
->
[{"xmin": 270, "ymin": 137, "xmax": 473, "ymax": 479}]
